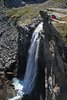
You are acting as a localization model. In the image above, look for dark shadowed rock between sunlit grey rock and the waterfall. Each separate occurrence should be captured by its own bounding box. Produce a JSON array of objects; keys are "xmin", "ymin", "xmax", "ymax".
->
[{"xmin": 17, "ymin": 26, "xmax": 32, "ymax": 78}]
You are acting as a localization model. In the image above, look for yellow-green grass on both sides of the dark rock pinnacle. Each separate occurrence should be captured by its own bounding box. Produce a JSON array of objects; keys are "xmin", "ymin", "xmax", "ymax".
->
[{"xmin": 6, "ymin": 0, "xmax": 67, "ymax": 42}]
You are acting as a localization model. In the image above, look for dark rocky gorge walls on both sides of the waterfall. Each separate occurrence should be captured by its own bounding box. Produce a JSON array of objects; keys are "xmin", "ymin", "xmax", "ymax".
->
[{"xmin": 0, "ymin": 0, "xmax": 67, "ymax": 100}]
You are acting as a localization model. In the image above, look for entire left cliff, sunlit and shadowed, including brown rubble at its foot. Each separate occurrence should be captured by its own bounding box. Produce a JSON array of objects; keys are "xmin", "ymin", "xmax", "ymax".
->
[{"xmin": 0, "ymin": 2, "xmax": 35, "ymax": 99}]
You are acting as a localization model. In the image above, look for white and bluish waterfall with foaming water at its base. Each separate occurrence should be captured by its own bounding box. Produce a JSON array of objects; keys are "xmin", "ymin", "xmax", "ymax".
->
[{"xmin": 8, "ymin": 22, "xmax": 43, "ymax": 100}]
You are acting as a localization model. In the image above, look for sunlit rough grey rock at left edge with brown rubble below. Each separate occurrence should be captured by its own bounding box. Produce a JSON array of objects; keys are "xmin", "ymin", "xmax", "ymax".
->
[{"xmin": 0, "ymin": 0, "xmax": 18, "ymax": 100}]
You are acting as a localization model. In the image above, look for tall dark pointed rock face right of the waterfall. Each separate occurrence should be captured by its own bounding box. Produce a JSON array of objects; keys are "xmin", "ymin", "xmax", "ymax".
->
[{"xmin": 40, "ymin": 11, "xmax": 67, "ymax": 98}]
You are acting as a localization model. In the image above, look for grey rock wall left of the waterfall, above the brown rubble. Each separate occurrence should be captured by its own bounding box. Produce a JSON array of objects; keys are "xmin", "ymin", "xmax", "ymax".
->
[{"xmin": 0, "ymin": 0, "xmax": 40, "ymax": 77}]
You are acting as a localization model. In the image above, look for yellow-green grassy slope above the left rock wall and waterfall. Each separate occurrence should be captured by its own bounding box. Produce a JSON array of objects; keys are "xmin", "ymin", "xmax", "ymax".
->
[{"xmin": 6, "ymin": 0, "xmax": 65, "ymax": 23}]
